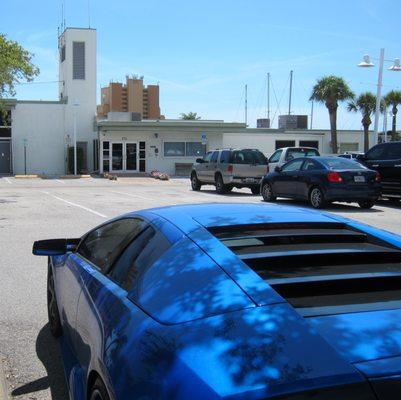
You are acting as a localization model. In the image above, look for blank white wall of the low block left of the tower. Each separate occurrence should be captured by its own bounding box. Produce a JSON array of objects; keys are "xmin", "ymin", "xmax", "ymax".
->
[{"xmin": 11, "ymin": 103, "xmax": 66, "ymax": 174}]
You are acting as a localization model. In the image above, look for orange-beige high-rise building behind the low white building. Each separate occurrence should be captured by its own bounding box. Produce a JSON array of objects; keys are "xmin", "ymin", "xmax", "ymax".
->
[{"xmin": 97, "ymin": 76, "xmax": 164, "ymax": 119}]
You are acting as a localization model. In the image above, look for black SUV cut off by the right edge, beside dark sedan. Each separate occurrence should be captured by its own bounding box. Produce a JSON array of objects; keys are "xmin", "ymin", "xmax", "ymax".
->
[{"xmin": 356, "ymin": 142, "xmax": 401, "ymax": 200}]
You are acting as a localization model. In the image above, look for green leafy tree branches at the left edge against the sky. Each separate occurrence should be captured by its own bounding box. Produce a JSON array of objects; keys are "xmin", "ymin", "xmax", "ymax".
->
[{"xmin": 0, "ymin": 33, "xmax": 39, "ymax": 111}]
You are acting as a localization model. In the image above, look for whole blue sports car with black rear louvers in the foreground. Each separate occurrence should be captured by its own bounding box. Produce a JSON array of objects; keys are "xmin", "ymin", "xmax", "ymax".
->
[{"xmin": 33, "ymin": 204, "xmax": 401, "ymax": 400}]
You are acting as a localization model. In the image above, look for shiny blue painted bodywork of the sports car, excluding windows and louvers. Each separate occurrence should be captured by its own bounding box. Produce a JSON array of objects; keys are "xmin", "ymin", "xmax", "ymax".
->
[{"xmin": 44, "ymin": 204, "xmax": 401, "ymax": 400}]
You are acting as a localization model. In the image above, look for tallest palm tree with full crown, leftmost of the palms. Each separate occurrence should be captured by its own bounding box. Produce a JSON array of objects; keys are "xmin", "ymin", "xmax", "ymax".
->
[{"xmin": 310, "ymin": 75, "xmax": 354, "ymax": 153}]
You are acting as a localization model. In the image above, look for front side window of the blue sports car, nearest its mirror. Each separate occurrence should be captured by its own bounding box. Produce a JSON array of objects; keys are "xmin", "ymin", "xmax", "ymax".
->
[{"xmin": 78, "ymin": 218, "xmax": 145, "ymax": 272}]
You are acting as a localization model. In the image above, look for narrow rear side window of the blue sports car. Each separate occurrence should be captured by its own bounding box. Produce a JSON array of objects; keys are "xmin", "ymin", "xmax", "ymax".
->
[{"xmin": 109, "ymin": 226, "xmax": 171, "ymax": 293}]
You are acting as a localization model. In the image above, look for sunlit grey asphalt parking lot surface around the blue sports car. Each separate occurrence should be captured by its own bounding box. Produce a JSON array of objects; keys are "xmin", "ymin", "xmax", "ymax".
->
[{"xmin": 0, "ymin": 177, "xmax": 401, "ymax": 400}]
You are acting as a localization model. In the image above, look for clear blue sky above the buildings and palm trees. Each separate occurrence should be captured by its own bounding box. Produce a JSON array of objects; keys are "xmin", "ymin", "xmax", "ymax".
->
[{"xmin": 0, "ymin": 0, "xmax": 401, "ymax": 129}]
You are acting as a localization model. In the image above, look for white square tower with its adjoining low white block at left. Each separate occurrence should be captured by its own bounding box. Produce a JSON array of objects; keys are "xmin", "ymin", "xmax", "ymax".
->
[{"xmin": 0, "ymin": 28, "xmax": 97, "ymax": 174}]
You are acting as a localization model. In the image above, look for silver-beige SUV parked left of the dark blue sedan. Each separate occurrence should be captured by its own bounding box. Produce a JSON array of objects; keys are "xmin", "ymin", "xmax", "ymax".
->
[{"xmin": 191, "ymin": 149, "xmax": 268, "ymax": 194}]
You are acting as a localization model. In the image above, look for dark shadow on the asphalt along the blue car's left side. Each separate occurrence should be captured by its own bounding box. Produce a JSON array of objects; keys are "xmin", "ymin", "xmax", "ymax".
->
[{"xmin": 11, "ymin": 324, "xmax": 68, "ymax": 400}]
